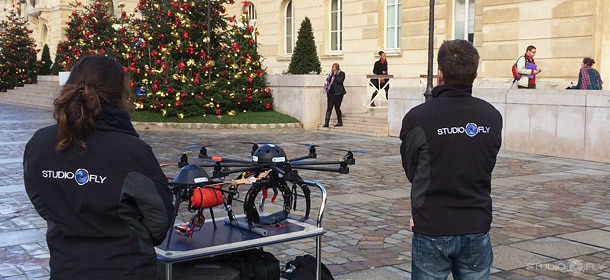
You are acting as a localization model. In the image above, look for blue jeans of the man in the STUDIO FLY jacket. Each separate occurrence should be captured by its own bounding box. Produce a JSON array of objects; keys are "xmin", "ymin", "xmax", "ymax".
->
[{"xmin": 411, "ymin": 232, "xmax": 493, "ymax": 280}]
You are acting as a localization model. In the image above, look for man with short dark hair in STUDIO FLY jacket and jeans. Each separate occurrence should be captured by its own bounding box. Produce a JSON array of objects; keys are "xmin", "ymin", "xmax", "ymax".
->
[{"xmin": 400, "ymin": 40, "xmax": 502, "ymax": 279}]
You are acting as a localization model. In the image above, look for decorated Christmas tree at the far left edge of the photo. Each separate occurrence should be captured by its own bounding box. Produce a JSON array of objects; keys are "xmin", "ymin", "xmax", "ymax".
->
[{"xmin": 0, "ymin": 3, "xmax": 38, "ymax": 92}]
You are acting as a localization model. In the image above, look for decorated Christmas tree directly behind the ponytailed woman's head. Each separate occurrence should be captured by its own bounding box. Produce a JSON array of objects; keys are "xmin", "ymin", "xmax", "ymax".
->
[{"xmin": 55, "ymin": 0, "xmax": 132, "ymax": 71}]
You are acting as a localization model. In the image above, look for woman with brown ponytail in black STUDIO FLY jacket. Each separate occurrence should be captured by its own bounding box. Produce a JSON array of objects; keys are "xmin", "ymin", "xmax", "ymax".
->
[{"xmin": 23, "ymin": 55, "xmax": 174, "ymax": 280}]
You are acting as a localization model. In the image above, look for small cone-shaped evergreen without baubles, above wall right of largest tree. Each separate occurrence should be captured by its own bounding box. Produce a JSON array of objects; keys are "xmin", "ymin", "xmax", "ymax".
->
[{"xmin": 288, "ymin": 17, "xmax": 322, "ymax": 74}]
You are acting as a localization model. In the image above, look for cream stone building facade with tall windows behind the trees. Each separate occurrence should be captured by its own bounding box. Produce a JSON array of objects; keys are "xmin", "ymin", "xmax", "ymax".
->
[{"xmin": 0, "ymin": 0, "xmax": 610, "ymax": 89}]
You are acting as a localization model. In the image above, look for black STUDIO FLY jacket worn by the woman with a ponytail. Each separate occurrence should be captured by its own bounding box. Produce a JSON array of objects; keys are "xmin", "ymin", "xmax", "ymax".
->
[{"xmin": 23, "ymin": 108, "xmax": 174, "ymax": 280}]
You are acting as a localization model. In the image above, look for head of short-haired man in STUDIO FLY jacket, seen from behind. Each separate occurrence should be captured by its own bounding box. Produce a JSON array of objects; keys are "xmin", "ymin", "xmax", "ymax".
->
[{"xmin": 437, "ymin": 40, "xmax": 479, "ymax": 88}]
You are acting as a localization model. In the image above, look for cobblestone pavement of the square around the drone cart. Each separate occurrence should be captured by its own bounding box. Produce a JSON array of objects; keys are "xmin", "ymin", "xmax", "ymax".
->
[{"xmin": 0, "ymin": 104, "xmax": 610, "ymax": 280}]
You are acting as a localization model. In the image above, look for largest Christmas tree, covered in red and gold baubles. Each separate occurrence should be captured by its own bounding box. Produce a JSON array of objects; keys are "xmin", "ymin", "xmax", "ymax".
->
[{"xmin": 129, "ymin": 0, "xmax": 271, "ymax": 118}]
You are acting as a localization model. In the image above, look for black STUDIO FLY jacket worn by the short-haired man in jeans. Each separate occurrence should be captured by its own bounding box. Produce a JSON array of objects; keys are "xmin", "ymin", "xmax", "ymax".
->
[{"xmin": 400, "ymin": 86, "xmax": 502, "ymax": 236}]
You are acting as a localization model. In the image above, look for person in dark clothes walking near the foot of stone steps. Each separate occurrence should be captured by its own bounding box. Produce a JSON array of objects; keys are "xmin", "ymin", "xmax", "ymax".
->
[{"xmin": 324, "ymin": 63, "xmax": 346, "ymax": 127}]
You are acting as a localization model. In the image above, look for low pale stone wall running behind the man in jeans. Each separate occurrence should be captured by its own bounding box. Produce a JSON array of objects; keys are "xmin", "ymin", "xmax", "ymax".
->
[{"xmin": 269, "ymin": 75, "xmax": 610, "ymax": 162}]
